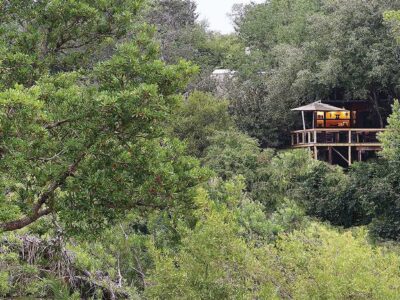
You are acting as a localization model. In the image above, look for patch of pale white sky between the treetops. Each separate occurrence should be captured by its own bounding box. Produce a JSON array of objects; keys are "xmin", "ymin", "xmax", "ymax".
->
[{"xmin": 195, "ymin": 0, "xmax": 264, "ymax": 33}]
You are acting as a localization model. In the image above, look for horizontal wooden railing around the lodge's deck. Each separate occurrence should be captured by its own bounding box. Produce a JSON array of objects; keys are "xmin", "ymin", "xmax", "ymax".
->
[{"xmin": 292, "ymin": 128, "xmax": 385, "ymax": 147}]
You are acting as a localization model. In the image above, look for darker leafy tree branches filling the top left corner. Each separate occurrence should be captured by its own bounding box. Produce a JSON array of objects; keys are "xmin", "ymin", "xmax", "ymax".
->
[{"xmin": 0, "ymin": 0, "xmax": 142, "ymax": 87}]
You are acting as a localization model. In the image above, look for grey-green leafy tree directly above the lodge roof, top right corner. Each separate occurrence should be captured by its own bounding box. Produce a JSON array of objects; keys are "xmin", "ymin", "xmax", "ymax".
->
[{"xmin": 304, "ymin": 0, "xmax": 399, "ymax": 127}]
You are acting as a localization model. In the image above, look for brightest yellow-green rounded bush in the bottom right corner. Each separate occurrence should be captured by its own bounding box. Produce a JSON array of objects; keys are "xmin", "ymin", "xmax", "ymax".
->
[{"xmin": 276, "ymin": 224, "xmax": 400, "ymax": 299}]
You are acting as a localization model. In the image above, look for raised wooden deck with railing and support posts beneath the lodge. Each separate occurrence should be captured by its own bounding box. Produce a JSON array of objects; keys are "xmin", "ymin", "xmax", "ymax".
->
[{"xmin": 292, "ymin": 128, "xmax": 385, "ymax": 165}]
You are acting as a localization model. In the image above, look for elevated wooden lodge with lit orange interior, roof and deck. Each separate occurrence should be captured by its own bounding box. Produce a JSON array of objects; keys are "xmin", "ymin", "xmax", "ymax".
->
[{"xmin": 291, "ymin": 101, "xmax": 384, "ymax": 166}]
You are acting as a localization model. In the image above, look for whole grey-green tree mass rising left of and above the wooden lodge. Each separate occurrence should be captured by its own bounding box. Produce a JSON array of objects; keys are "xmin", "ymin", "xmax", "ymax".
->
[{"xmin": 229, "ymin": 0, "xmax": 400, "ymax": 147}]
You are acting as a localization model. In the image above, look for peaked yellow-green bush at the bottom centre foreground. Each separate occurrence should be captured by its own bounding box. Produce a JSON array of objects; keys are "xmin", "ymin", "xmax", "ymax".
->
[{"xmin": 145, "ymin": 191, "xmax": 275, "ymax": 299}]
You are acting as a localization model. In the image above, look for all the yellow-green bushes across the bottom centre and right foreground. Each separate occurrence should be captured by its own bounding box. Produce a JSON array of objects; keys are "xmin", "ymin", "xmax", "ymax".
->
[{"xmin": 146, "ymin": 196, "xmax": 400, "ymax": 299}]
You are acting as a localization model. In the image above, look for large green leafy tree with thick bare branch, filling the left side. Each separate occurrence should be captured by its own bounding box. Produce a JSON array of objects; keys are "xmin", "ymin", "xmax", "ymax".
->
[{"xmin": 0, "ymin": 0, "xmax": 203, "ymax": 231}]
